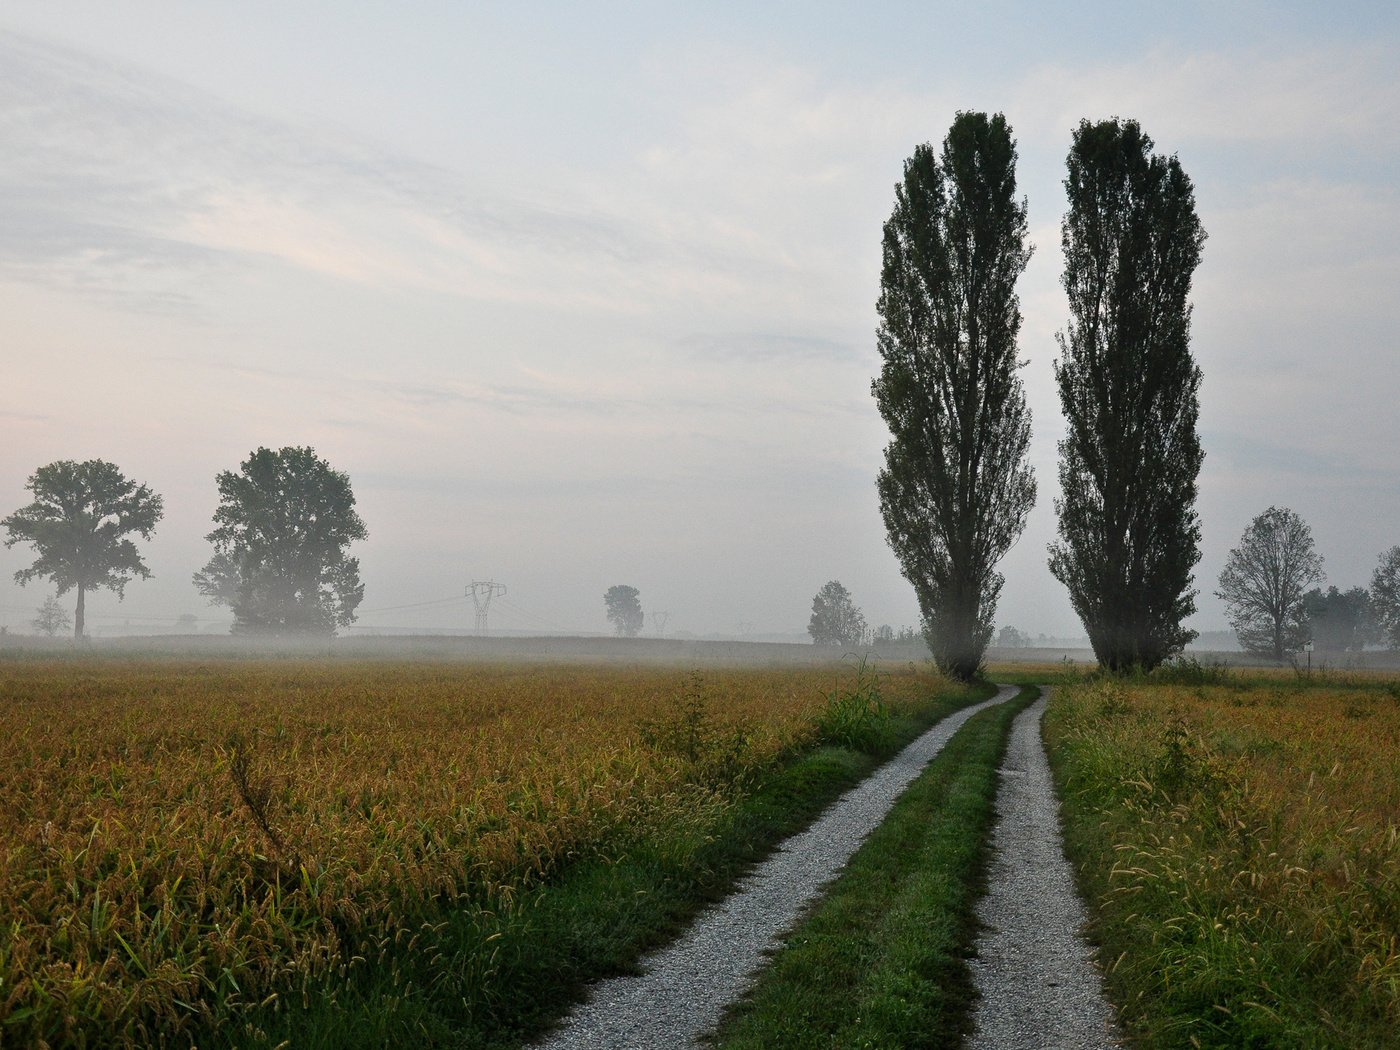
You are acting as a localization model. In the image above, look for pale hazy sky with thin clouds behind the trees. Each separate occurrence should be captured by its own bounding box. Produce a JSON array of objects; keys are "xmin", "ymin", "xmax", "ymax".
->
[{"xmin": 0, "ymin": 0, "xmax": 1400, "ymax": 637}]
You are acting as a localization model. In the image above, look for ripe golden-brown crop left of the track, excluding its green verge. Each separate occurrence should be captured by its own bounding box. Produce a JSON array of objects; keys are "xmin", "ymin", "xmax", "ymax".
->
[{"xmin": 0, "ymin": 659, "xmax": 952, "ymax": 1046}]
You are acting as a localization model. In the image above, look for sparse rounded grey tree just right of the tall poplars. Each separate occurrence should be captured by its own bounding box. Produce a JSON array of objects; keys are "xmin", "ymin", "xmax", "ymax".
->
[{"xmin": 1215, "ymin": 507, "xmax": 1323, "ymax": 659}]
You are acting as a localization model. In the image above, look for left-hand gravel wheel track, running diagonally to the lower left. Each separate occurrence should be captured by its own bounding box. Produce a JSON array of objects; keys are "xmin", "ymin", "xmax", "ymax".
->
[{"xmin": 538, "ymin": 686, "xmax": 1016, "ymax": 1050}]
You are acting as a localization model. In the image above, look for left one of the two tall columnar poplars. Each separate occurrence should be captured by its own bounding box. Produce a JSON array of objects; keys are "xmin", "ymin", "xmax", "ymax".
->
[{"xmin": 872, "ymin": 113, "xmax": 1036, "ymax": 679}]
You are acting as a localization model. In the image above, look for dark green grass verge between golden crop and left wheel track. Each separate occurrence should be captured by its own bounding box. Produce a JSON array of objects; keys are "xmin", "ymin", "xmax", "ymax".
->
[{"xmin": 226, "ymin": 686, "xmax": 991, "ymax": 1049}]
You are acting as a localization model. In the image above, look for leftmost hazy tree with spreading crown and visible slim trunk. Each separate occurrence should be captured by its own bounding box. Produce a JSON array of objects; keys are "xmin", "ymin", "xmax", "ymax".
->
[{"xmin": 0, "ymin": 459, "xmax": 162, "ymax": 638}]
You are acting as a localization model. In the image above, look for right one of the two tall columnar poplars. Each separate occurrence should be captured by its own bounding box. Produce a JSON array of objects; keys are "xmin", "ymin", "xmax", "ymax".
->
[{"xmin": 1050, "ymin": 119, "xmax": 1205, "ymax": 671}]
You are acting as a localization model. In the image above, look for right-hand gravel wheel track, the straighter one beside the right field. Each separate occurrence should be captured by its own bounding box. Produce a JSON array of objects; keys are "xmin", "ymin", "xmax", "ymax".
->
[{"xmin": 970, "ymin": 696, "xmax": 1120, "ymax": 1050}]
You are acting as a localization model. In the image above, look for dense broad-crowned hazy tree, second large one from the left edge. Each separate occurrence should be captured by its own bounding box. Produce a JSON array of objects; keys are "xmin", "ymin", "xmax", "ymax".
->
[{"xmin": 195, "ymin": 448, "xmax": 368, "ymax": 634}]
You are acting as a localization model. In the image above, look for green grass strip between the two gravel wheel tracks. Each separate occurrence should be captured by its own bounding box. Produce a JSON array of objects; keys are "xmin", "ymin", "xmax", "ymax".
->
[{"xmin": 713, "ymin": 687, "xmax": 1039, "ymax": 1050}]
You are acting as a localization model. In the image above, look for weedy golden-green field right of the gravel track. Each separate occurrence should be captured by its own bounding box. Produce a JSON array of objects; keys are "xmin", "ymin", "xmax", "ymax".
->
[{"xmin": 1044, "ymin": 666, "xmax": 1400, "ymax": 1050}]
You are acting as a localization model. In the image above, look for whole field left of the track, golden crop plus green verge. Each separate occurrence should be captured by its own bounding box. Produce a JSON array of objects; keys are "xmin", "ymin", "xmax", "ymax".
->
[{"xmin": 0, "ymin": 658, "xmax": 970, "ymax": 1046}]
